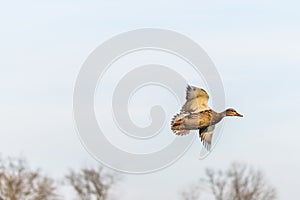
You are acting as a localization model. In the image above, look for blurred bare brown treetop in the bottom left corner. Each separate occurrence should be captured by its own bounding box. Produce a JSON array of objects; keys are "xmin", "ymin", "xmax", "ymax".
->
[{"xmin": 0, "ymin": 157, "xmax": 57, "ymax": 200}]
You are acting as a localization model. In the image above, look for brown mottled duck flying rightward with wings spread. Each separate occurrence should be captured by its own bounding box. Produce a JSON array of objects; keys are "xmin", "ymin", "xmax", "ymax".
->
[{"xmin": 171, "ymin": 86, "xmax": 243, "ymax": 150}]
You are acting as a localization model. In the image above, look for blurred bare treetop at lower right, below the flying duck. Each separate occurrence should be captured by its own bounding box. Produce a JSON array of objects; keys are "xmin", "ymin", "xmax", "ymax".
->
[{"xmin": 206, "ymin": 163, "xmax": 276, "ymax": 200}]
